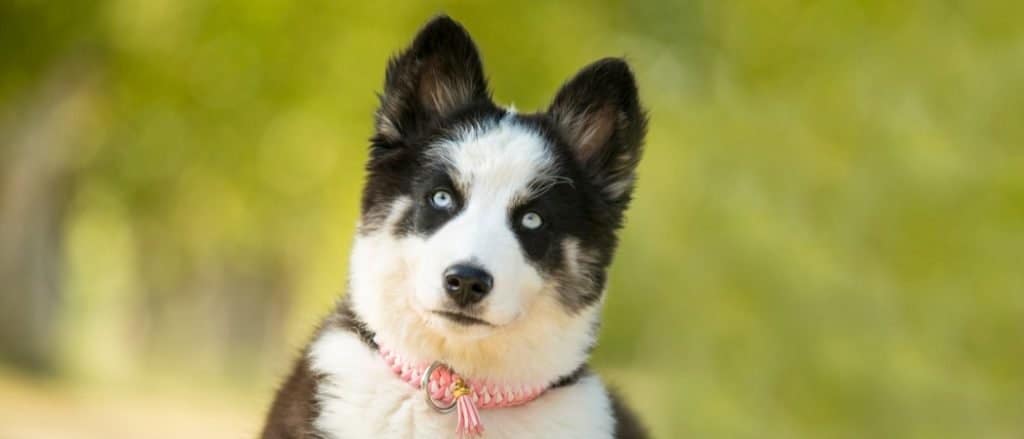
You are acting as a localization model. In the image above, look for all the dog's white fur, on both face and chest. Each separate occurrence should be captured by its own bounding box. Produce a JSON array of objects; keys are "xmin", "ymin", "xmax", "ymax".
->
[{"xmin": 319, "ymin": 120, "xmax": 613, "ymax": 438}]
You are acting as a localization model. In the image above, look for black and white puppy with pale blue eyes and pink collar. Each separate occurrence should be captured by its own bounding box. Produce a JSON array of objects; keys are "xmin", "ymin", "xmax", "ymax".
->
[{"xmin": 263, "ymin": 16, "xmax": 646, "ymax": 439}]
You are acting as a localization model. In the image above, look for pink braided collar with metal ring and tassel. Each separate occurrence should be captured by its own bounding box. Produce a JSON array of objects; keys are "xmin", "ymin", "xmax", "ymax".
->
[{"xmin": 375, "ymin": 341, "xmax": 550, "ymax": 437}]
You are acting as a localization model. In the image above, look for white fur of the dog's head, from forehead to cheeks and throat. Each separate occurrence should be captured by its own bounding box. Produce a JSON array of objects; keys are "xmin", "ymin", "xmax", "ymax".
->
[{"xmin": 350, "ymin": 121, "xmax": 600, "ymax": 382}]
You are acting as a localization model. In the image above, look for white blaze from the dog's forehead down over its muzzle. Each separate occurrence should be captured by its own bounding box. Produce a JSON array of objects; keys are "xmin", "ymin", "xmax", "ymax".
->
[{"xmin": 416, "ymin": 119, "xmax": 555, "ymax": 325}]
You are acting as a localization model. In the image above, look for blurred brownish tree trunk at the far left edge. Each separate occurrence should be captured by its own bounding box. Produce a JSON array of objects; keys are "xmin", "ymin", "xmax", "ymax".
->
[{"xmin": 0, "ymin": 61, "xmax": 95, "ymax": 374}]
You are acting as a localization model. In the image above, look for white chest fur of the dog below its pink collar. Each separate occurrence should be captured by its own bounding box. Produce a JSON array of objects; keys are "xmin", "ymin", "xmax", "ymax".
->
[{"xmin": 310, "ymin": 331, "xmax": 614, "ymax": 439}]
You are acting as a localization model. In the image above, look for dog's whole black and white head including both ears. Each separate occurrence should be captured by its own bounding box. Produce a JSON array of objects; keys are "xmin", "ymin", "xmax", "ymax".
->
[{"xmin": 351, "ymin": 17, "xmax": 645, "ymax": 380}]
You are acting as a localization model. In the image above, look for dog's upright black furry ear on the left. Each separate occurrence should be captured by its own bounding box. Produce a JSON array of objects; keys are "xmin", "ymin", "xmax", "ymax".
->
[{"xmin": 376, "ymin": 15, "xmax": 489, "ymax": 142}]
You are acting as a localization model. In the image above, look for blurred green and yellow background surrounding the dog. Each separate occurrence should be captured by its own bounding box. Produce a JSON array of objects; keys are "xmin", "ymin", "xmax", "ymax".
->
[{"xmin": 0, "ymin": 0, "xmax": 1024, "ymax": 439}]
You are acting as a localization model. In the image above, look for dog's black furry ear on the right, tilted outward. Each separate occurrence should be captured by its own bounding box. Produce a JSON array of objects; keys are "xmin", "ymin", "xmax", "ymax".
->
[{"xmin": 548, "ymin": 58, "xmax": 647, "ymax": 208}]
